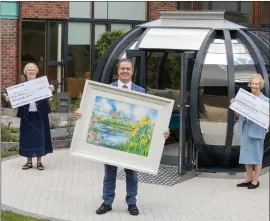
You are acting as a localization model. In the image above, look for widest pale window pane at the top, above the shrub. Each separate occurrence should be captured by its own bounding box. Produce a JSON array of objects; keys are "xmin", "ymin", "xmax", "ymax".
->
[{"xmin": 108, "ymin": 1, "xmax": 146, "ymax": 21}]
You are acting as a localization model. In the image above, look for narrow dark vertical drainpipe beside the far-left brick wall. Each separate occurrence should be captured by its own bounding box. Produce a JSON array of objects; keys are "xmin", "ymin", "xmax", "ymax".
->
[{"xmin": 16, "ymin": 2, "xmax": 22, "ymax": 84}]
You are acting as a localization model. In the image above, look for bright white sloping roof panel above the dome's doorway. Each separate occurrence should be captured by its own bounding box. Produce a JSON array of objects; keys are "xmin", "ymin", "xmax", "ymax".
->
[{"xmin": 140, "ymin": 28, "xmax": 209, "ymax": 50}]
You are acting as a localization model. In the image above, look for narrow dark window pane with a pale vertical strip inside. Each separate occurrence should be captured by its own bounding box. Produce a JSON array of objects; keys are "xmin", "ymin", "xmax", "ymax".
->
[{"xmin": 49, "ymin": 22, "xmax": 64, "ymax": 62}]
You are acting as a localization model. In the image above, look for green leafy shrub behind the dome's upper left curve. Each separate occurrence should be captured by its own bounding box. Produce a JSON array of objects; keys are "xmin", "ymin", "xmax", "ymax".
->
[{"xmin": 96, "ymin": 30, "xmax": 124, "ymax": 59}]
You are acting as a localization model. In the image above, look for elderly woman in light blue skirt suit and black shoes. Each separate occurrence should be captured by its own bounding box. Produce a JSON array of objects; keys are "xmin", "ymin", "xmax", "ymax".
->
[{"xmin": 231, "ymin": 74, "xmax": 269, "ymax": 189}]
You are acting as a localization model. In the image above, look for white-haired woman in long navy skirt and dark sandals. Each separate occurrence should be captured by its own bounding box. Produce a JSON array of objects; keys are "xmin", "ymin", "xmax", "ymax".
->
[{"xmin": 5, "ymin": 63, "xmax": 54, "ymax": 170}]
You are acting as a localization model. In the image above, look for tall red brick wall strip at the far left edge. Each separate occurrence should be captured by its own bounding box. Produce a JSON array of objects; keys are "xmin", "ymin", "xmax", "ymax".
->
[{"xmin": 1, "ymin": 20, "xmax": 18, "ymax": 90}]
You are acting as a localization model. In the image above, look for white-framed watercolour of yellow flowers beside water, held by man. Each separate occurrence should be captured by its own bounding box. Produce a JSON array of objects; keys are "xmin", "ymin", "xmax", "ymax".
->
[{"xmin": 70, "ymin": 80, "xmax": 174, "ymax": 174}]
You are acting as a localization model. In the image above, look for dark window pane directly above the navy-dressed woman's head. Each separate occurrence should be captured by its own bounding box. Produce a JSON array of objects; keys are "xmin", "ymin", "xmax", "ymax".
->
[{"xmin": 21, "ymin": 21, "xmax": 46, "ymax": 75}]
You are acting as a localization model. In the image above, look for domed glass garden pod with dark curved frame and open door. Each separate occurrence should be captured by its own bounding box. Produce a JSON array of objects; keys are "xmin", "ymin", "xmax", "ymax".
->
[{"xmin": 93, "ymin": 11, "xmax": 270, "ymax": 173}]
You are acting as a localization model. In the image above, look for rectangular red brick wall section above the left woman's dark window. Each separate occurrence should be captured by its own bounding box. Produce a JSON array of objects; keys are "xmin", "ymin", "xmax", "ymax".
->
[{"xmin": 22, "ymin": 1, "xmax": 69, "ymax": 19}]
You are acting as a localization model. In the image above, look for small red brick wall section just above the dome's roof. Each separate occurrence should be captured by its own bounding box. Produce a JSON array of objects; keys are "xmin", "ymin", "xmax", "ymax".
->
[{"xmin": 148, "ymin": 1, "xmax": 177, "ymax": 21}]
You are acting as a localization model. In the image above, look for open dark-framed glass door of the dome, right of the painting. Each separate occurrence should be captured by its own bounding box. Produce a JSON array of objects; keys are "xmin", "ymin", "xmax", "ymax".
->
[{"xmin": 178, "ymin": 52, "xmax": 196, "ymax": 175}]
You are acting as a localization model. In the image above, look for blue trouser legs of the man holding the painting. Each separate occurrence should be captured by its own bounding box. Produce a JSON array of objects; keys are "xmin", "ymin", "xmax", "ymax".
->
[{"xmin": 102, "ymin": 164, "xmax": 138, "ymax": 205}]
